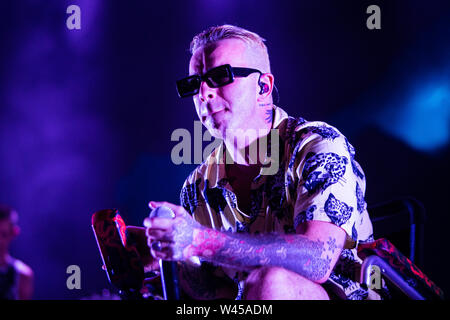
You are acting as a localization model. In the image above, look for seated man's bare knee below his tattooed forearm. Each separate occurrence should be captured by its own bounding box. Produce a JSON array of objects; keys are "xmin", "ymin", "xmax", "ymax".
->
[{"xmin": 244, "ymin": 267, "xmax": 329, "ymax": 300}]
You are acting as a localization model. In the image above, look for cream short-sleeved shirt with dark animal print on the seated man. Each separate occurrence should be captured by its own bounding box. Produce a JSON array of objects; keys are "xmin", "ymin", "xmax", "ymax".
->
[{"xmin": 180, "ymin": 107, "xmax": 379, "ymax": 300}]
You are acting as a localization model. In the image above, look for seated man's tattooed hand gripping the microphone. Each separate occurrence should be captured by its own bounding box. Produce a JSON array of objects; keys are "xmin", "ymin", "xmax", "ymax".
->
[{"xmin": 144, "ymin": 201, "xmax": 202, "ymax": 260}]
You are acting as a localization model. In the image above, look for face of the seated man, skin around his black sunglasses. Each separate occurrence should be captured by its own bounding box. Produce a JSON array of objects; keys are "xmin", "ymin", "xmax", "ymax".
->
[{"xmin": 189, "ymin": 39, "xmax": 267, "ymax": 139}]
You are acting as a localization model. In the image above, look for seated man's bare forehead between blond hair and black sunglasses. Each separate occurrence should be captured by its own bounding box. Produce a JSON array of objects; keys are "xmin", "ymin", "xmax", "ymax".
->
[{"xmin": 189, "ymin": 39, "xmax": 248, "ymax": 74}]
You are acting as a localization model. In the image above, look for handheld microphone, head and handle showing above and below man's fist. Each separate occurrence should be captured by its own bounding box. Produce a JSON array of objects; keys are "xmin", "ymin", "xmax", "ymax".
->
[{"xmin": 149, "ymin": 206, "xmax": 180, "ymax": 300}]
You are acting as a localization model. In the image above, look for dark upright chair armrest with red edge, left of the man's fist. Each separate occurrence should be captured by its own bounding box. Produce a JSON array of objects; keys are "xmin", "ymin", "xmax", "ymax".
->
[{"xmin": 92, "ymin": 209, "xmax": 145, "ymax": 299}]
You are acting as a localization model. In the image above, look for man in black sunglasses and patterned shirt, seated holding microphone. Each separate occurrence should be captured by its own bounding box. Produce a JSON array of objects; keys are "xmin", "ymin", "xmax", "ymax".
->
[{"xmin": 144, "ymin": 25, "xmax": 376, "ymax": 300}]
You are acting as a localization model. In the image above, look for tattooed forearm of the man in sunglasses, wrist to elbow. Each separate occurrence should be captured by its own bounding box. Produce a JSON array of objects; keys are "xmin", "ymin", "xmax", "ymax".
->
[{"xmin": 186, "ymin": 228, "xmax": 338, "ymax": 282}]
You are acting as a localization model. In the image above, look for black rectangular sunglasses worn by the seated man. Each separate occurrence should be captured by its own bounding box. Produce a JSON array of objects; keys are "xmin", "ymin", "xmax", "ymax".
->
[{"xmin": 177, "ymin": 64, "xmax": 262, "ymax": 98}]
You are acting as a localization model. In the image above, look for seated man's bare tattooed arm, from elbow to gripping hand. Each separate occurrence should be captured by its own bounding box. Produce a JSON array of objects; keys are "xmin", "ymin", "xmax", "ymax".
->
[{"xmin": 144, "ymin": 203, "xmax": 346, "ymax": 283}]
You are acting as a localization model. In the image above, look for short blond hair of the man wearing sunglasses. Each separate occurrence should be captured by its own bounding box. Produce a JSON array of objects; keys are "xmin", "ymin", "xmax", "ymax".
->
[{"xmin": 190, "ymin": 24, "xmax": 270, "ymax": 72}]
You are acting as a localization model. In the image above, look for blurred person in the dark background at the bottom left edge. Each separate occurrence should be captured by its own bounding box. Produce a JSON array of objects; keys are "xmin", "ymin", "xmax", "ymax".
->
[{"xmin": 0, "ymin": 205, "xmax": 34, "ymax": 300}]
